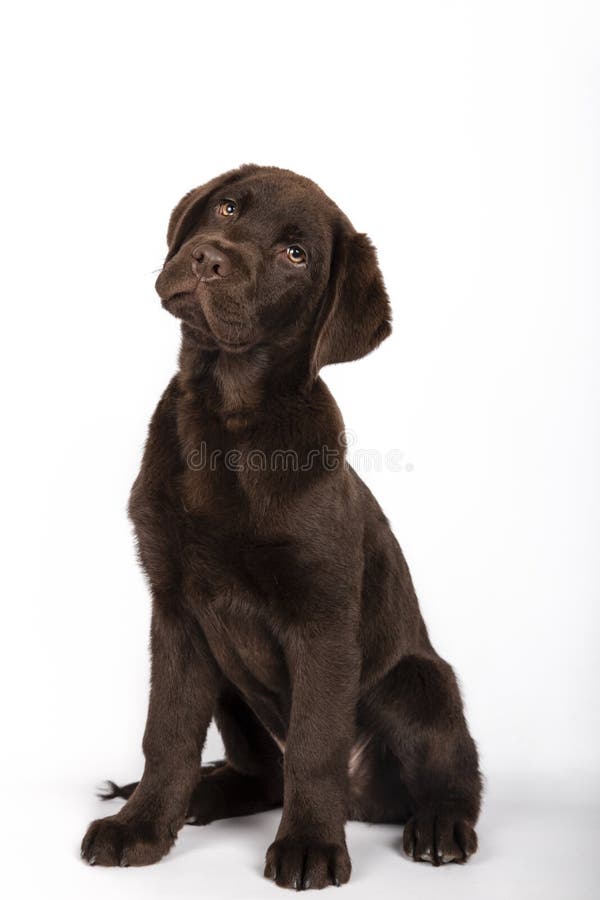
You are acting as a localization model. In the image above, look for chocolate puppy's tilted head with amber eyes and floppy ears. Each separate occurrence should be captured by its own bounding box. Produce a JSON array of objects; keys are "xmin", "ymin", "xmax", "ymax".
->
[{"xmin": 156, "ymin": 165, "xmax": 390, "ymax": 375}]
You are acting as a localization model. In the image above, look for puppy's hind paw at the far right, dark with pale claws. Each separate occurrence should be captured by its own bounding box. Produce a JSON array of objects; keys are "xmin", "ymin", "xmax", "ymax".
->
[{"xmin": 403, "ymin": 811, "xmax": 477, "ymax": 866}]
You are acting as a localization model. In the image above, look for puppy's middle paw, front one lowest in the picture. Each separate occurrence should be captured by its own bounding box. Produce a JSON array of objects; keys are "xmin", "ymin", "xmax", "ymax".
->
[{"xmin": 265, "ymin": 837, "xmax": 352, "ymax": 891}]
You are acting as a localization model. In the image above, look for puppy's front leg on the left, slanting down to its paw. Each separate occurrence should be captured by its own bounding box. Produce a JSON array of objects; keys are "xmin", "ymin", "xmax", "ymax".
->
[{"xmin": 81, "ymin": 600, "xmax": 219, "ymax": 866}]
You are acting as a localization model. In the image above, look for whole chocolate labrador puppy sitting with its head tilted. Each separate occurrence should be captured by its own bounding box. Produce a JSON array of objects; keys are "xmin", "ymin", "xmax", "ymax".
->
[{"xmin": 82, "ymin": 165, "xmax": 481, "ymax": 889}]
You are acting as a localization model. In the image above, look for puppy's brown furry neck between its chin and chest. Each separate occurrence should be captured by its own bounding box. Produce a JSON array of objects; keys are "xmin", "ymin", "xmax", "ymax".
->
[{"xmin": 179, "ymin": 327, "xmax": 310, "ymax": 432}]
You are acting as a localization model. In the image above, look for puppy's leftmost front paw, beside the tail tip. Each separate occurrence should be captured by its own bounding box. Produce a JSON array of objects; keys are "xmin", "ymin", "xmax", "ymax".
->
[{"xmin": 81, "ymin": 813, "xmax": 177, "ymax": 866}]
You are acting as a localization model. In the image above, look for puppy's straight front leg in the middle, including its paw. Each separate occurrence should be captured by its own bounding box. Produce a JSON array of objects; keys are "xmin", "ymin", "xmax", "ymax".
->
[{"xmin": 265, "ymin": 617, "xmax": 360, "ymax": 890}]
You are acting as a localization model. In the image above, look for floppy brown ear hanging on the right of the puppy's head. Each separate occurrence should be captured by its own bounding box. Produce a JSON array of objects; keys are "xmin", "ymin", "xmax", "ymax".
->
[{"xmin": 311, "ymin": 231, "xmax": 392, "ymax": 376}]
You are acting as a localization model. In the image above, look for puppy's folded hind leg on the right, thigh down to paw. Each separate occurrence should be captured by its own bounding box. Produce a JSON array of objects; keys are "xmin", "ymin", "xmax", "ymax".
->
[{"xmin": 361, "ymin": 655, "xmax": 481, "ymax": 866}]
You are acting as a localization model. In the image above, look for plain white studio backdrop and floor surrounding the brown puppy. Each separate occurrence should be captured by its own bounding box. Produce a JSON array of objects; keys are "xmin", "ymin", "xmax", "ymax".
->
[{"xmin": 0, "ymin": 0, "xmax": 600, "ymax": 900}]
